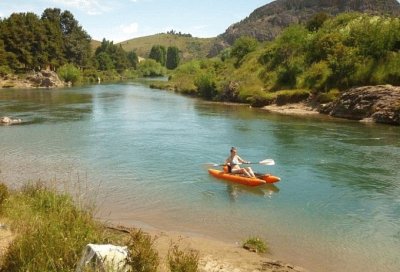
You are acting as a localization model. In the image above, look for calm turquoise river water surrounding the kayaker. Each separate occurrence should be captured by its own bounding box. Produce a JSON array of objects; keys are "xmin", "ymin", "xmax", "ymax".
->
[{"xmin": 0, "ymin": 83, "xmax": 400, "ymax": 271}]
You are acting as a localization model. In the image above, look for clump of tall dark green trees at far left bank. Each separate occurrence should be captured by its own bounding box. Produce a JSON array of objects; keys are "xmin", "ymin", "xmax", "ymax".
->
[{"xmin": 0, "ymin": 8, "xmax": 91, "ymax": 70}]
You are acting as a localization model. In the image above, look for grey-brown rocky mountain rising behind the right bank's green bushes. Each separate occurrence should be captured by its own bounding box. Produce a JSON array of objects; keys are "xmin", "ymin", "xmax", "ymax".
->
[{"xmin": 218, "ymin": 0, "xmax": 400, "ymax": 44}]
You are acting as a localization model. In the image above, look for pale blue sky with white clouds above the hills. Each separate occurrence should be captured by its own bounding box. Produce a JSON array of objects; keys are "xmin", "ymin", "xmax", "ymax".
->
[{"xmin": 0, "ymin": 0, "xmax": 272, "ymax": 43}]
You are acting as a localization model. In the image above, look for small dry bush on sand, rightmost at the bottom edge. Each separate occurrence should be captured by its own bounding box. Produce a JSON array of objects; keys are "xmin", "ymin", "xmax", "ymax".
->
[{"xmin": 168, "ymin": 245, "xmax": 199, "ymax": 272}]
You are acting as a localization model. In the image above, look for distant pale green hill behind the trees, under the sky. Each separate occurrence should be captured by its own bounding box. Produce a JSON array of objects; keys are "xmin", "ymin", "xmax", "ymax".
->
[{"xmin": 116, "ymin": 33, "xmax": 214, "ymax": 61}]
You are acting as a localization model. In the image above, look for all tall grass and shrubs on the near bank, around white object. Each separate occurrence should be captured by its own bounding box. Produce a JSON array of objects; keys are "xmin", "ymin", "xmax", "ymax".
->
[{"xmin": 0, "ymin": 183, "xmax": 198, "ymax": 272}]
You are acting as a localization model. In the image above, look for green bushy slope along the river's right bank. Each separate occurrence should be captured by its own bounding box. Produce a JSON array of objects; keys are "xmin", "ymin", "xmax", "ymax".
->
[{"xmin": 157, "ymin": 13, "xmax": 400, "ymax": 106}]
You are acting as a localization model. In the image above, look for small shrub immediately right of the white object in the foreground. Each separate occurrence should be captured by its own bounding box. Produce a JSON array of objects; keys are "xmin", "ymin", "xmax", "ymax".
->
[{"xmin": 126, "ymin": 230, "xmax": 160, "ymax": 272}]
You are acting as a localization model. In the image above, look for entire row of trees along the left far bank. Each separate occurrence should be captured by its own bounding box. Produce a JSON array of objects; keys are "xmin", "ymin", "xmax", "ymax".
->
[{"xmin": 0, "ymin": 8, "xmax": 180, "ymax": 82}]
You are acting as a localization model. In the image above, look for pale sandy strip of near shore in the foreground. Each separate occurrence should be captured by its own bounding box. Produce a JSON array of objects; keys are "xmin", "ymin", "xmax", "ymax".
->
[{"xmin": 0, "ymin": 222, "xmax": 307, "ymax": 272}]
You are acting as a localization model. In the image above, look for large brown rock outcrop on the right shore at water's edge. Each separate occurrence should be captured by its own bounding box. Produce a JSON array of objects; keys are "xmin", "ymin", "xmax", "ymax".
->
[{"xmin": 319, "ymin": 85, "xmax": 400, "ymax": 125}]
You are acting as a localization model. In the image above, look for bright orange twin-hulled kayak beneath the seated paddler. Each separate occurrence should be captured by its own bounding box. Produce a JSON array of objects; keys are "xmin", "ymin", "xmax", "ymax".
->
[{"xmin": 208, "ymin": 169, "xmax": 281, "ymax": 186}]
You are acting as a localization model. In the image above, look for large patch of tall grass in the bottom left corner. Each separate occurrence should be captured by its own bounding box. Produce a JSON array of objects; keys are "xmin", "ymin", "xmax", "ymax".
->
[{"xmin": 0, "ymin": 183, "xmax": 110, "ymax": 272}]
